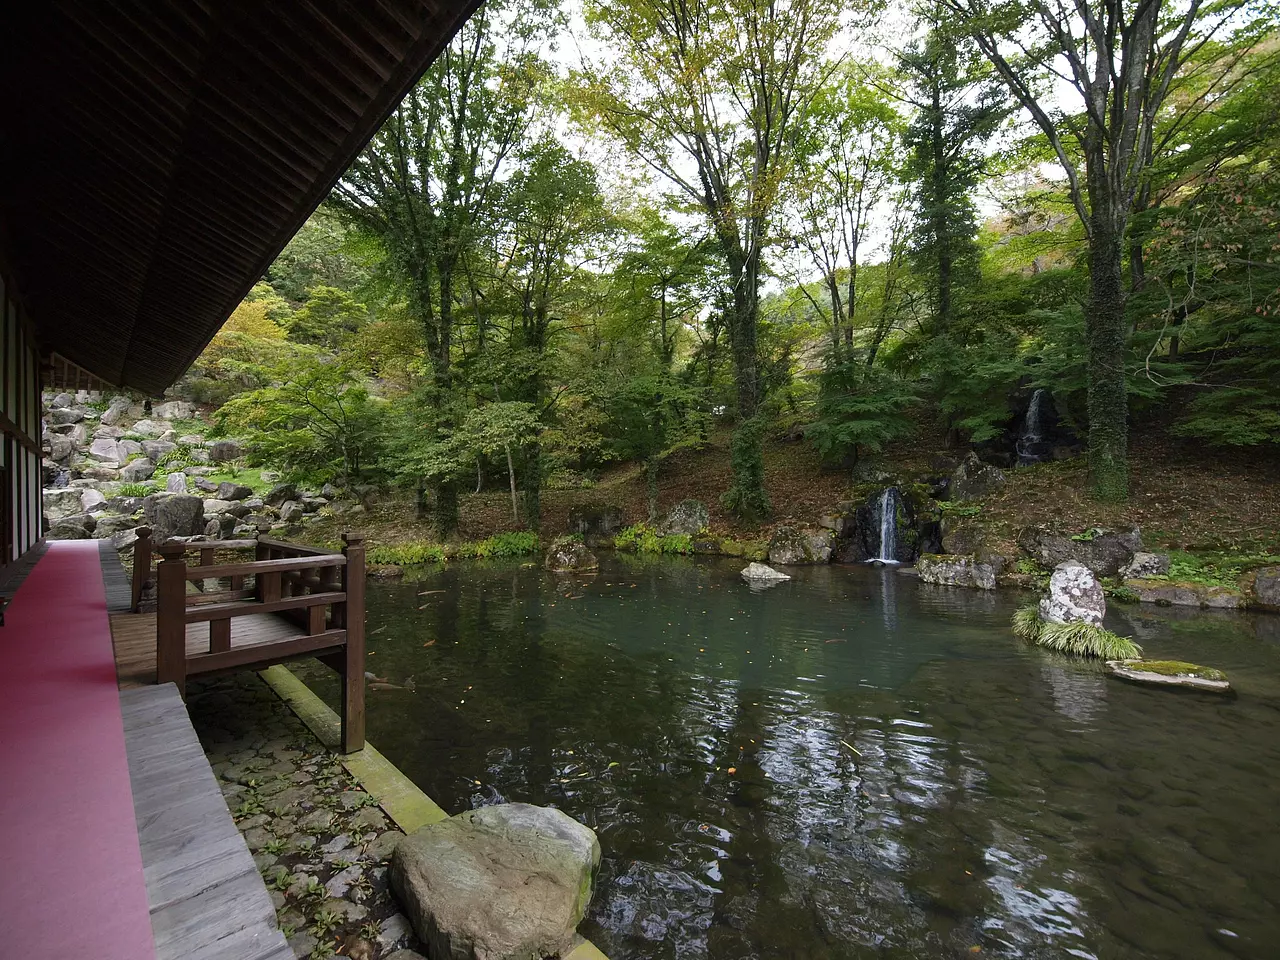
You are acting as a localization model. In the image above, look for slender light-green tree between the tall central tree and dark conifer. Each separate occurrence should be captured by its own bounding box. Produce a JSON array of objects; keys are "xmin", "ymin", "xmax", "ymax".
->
[{"xmin": 787, "ymin": 64, "xmax": 902, "ymax": 348}]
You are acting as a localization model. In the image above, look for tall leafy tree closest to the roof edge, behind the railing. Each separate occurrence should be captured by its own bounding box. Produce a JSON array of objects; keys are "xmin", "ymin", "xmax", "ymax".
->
[{"xmin": 329, "ymin": 0, "xmax": 554, "ymax": 538}]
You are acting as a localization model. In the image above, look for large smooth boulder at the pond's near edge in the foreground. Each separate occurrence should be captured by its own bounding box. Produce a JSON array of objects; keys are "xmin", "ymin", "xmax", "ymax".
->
[{"xmin": 390, "ymin": 804, "xmax": 600, "ymax": 960}]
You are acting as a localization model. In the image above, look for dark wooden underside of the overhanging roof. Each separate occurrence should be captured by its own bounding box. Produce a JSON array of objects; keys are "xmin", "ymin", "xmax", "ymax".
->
[{"xmin": 0, "ymin": 0, "xmax": 479, "ymax": 393}]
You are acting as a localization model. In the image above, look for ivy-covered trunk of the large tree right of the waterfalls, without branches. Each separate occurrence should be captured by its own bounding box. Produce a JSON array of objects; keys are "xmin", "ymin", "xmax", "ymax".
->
[{"xmin": 1084, "ymin": 217, "xmax": 1129, "ymax": 503}]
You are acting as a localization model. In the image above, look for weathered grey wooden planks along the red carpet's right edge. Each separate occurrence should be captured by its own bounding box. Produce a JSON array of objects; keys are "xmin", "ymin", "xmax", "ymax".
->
[{"xmin": 120, "ymin": 686, "xmax": 293, "ymax": 960}]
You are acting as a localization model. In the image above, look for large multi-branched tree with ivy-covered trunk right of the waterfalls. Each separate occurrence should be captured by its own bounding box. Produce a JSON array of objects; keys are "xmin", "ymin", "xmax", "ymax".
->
[{"xmin": 941, "ymin": 0, "xmax": 1264, "ymax": 500}]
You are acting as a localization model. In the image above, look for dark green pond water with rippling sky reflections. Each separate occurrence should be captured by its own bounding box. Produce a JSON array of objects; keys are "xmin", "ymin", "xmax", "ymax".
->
[{"xmin": 294, "ymin": 556, "xmax": 1280, "ymax": 960}]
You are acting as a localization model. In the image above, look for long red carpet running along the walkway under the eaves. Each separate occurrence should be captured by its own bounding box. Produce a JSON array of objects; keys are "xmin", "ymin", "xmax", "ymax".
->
[{"xmin": 0, "ymin": 541, "xmax": 155, "ymax": 960}]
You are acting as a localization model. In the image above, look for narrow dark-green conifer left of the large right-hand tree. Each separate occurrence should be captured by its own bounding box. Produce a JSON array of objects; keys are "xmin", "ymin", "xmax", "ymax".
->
[{"xmin": 899, "ymin": 13, "xmax": 1007, "ymax": 335}]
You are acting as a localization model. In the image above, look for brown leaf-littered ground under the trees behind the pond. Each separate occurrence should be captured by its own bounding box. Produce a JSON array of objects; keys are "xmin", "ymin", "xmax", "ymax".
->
[{"xmin": 312, "ymin": 430, "xmax": 1280, "ymax": 556}]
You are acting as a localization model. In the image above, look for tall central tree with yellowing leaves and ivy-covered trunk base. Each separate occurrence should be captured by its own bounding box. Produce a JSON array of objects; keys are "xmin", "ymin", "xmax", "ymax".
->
[{"xmin": 580, "ymin": 0, "xmax": 847, "ymax": 518}]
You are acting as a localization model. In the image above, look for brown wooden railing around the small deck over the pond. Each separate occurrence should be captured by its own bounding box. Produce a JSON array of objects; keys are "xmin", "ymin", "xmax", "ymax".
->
[{"xmin": 153, "ymin": 531, "xmax": 365, "ymax": 753}]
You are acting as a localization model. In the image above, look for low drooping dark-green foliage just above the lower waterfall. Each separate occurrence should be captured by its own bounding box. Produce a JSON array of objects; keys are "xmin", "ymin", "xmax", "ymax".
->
[{"xmin": 805, "ymin": 358, "xmax": 916, "ymax": 465}]
